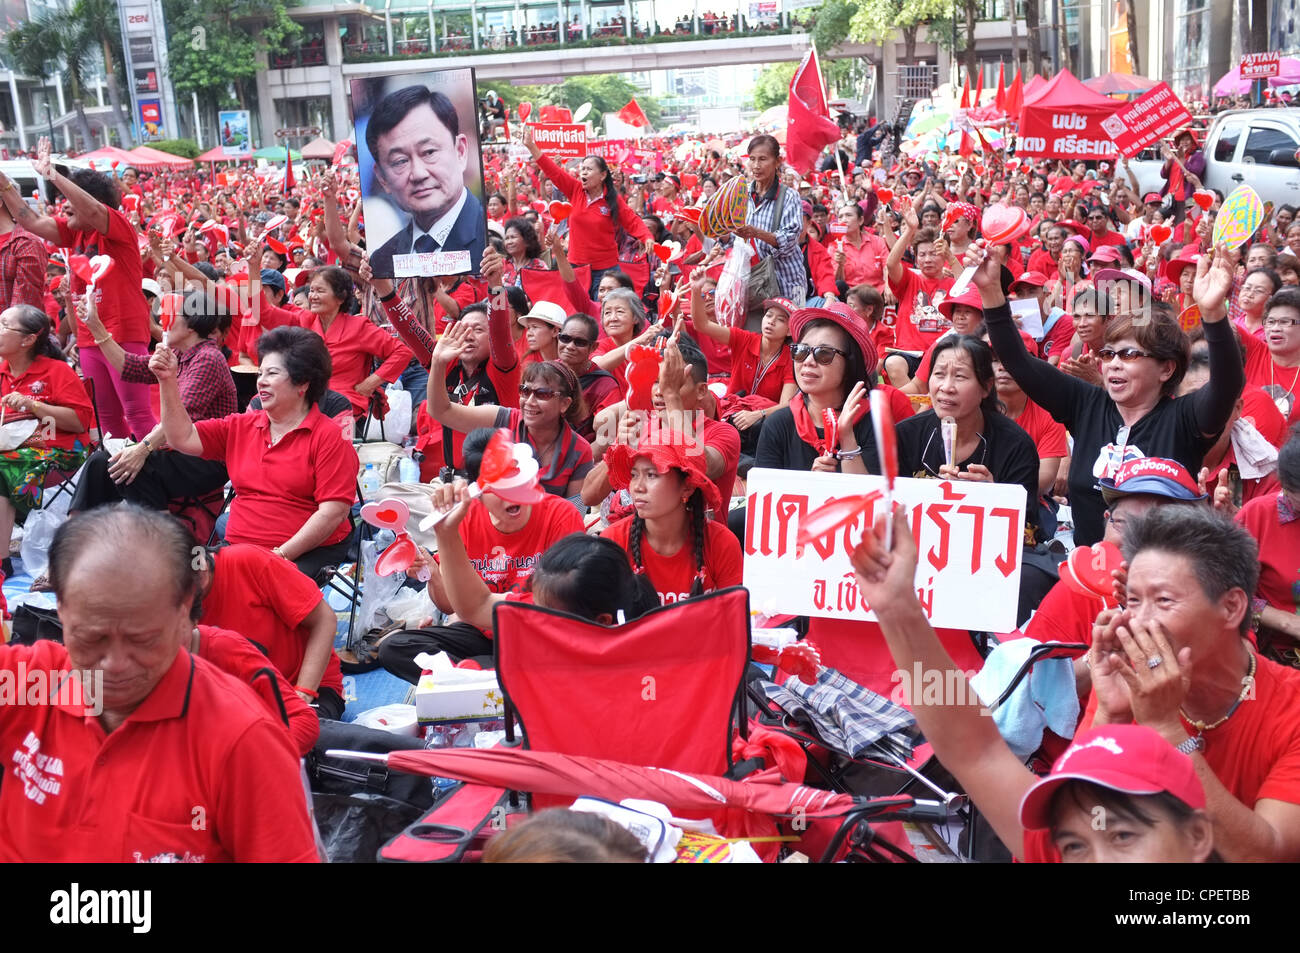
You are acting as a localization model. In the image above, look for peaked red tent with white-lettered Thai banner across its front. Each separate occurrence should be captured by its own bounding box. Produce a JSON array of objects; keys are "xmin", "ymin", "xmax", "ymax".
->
[{"xmin": 1015, "ymin": 70, "xmax": 1122, "ymax": 160}]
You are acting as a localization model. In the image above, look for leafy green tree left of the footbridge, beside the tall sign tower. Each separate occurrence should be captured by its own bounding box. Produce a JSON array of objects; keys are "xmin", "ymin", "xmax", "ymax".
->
[{"xmin": 163, "ymin": 0, "xmax": 302, "ymax": 109}]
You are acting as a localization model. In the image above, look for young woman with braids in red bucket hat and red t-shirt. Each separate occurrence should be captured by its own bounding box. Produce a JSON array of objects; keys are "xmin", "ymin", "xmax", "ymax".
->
[{"xmin": 602, "ymin": 429, "xmax": 741, "ymax": 605}]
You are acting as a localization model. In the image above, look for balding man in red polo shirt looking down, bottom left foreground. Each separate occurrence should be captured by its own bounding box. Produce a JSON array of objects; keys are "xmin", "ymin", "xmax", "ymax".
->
[{"xmin": 0, "ymin": 504, "xmax": 317, "ymax": 863}]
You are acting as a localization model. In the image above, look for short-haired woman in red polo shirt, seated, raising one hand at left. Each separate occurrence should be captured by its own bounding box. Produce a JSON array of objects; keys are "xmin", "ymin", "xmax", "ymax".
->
[{"xmin": 150, "ymin": 328, "xmax": 359, "ymax": 576}]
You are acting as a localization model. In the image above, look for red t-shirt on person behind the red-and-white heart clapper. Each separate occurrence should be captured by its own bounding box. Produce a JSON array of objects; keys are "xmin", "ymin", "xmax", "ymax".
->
[{"xmin": 459, "ymin": 495, "xmax": 584, "ymax": 593}]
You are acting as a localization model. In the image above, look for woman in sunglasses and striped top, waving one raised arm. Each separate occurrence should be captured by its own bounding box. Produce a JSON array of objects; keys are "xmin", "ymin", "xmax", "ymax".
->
[{"xmin": 429, "ymin": 322, "xmax": 592, "ymax": 498}]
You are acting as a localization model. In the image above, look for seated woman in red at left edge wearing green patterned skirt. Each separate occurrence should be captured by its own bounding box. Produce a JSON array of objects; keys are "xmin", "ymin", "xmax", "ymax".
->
[{"xmin": 0, "ymin": 304, "xmax": 95, "ymax": 576}]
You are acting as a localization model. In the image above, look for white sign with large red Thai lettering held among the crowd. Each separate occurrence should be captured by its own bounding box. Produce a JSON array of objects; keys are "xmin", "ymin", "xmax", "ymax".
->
[{"xmin": 744, "ymin": 469, "xmax": 1026, "ymax": 632}]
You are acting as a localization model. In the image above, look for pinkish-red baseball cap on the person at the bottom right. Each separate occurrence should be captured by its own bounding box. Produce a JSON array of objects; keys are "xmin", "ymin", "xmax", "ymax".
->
[{"xmin": 1021, "ymin": 724, "xmax": 1205, "ymax": 831}]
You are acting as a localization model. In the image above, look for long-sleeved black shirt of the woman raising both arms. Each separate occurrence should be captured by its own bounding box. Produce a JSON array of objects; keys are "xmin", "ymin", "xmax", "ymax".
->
[{"xmin": 984, "ymin": 304, "xmax": 1245, "ymax": 546}]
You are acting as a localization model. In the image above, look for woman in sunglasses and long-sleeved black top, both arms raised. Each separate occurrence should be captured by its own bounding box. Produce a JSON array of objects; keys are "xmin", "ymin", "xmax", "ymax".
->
[{"xmin": 966, "ymin": 246, "xmax": 1245, "ymax": 546}]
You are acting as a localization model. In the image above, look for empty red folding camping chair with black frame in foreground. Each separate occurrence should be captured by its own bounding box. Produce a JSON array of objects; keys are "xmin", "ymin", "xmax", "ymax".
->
[{"xmin": 380, "ymin": 586, "xmax": 749, "ymax": 862}]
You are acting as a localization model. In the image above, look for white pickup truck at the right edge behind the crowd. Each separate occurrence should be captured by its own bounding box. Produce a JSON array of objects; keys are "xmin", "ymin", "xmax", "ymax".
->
[{"xmin": 1128, "ymin": 109, "xmax": 1300, "ymax": 208}]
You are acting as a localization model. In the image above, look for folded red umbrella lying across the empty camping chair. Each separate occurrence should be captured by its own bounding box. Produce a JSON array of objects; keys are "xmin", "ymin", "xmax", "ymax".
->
[{"xmin": 325, "ymin": 748, "xmax": 878, "ymax": 818}]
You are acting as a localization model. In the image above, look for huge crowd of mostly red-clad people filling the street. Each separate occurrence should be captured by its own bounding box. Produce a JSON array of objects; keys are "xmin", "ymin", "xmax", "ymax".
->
[{"xmin": 0, "ymin": 70, "xmax": 1300, "ymax": 861}]
